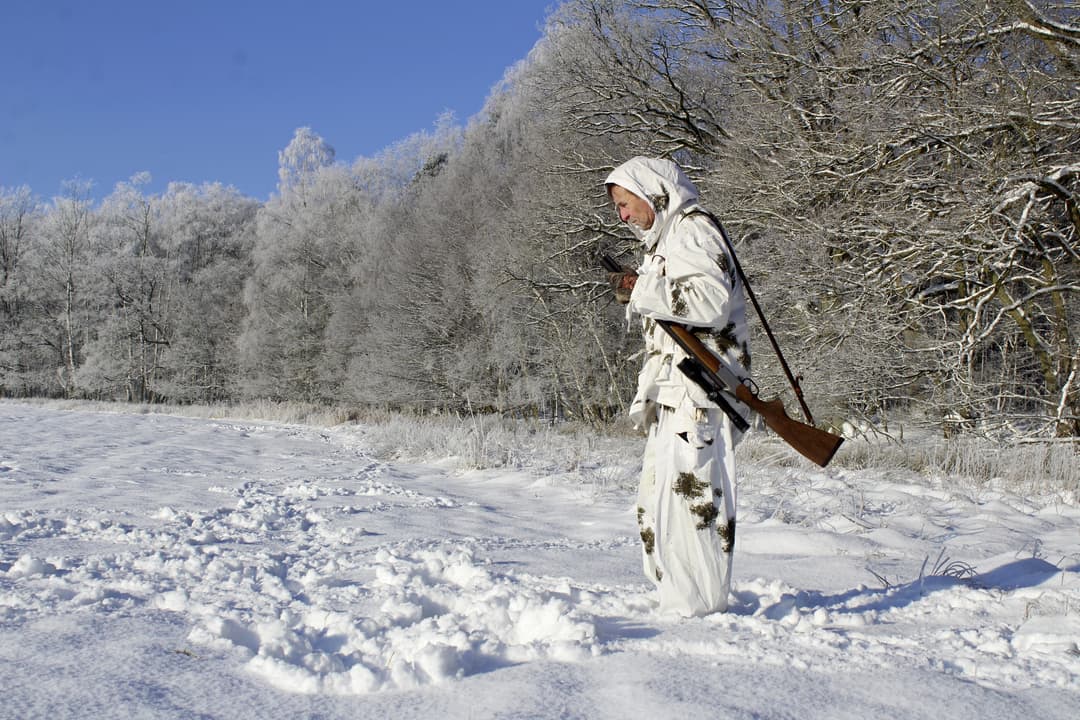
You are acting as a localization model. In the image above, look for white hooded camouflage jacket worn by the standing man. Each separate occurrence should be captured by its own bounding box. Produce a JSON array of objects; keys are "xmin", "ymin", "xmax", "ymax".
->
[{"xmin": 605, "ymin": 158, "xmax": 750, "ymax": 426}]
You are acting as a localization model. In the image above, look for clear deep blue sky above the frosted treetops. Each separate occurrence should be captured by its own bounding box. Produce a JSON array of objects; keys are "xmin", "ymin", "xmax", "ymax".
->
[{"xmin": 0, "ymin": 0, "xmax": 556, "ymax": 200}]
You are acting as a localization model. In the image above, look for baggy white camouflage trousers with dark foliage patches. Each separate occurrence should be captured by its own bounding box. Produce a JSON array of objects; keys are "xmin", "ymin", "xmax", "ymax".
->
[{"xmin": 637, "ymin": 406, "xmax": 735, "ymax": 617}]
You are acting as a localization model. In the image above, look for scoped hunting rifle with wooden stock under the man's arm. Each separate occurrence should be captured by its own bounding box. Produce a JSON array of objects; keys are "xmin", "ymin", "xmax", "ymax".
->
[{"xmin": 602, "ymin": 255, "xmax": 843, "ymax": 467}]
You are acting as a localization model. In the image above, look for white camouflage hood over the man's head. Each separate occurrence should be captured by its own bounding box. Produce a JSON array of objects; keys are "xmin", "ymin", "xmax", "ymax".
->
[{"xmin": 604, "ymin": 157, "xmax": 698, "ymax": 249}]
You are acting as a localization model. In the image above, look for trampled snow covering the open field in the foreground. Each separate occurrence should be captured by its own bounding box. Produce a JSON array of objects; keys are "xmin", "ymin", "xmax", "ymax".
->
[{"xmin": 0, "ymin": 402, "xmax": 1080, "ymax": 720}]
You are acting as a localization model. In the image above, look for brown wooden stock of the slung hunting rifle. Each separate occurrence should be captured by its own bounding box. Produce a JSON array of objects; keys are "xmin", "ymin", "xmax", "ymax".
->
[{"xmin": 657, "ymin": 320, "xmax": 843, "ymax": 467}]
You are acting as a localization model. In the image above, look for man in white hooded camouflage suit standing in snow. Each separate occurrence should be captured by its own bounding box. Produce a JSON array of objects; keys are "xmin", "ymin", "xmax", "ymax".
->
[{"xmin": 605, "ymin": 158, "xmax": 750, "ymax": 616}]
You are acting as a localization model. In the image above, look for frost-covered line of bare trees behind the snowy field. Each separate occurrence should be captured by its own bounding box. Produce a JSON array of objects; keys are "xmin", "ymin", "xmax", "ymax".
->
[{"xmin": 0, "ymin": 0, "xmax": 1080, "ymax": 438}]
